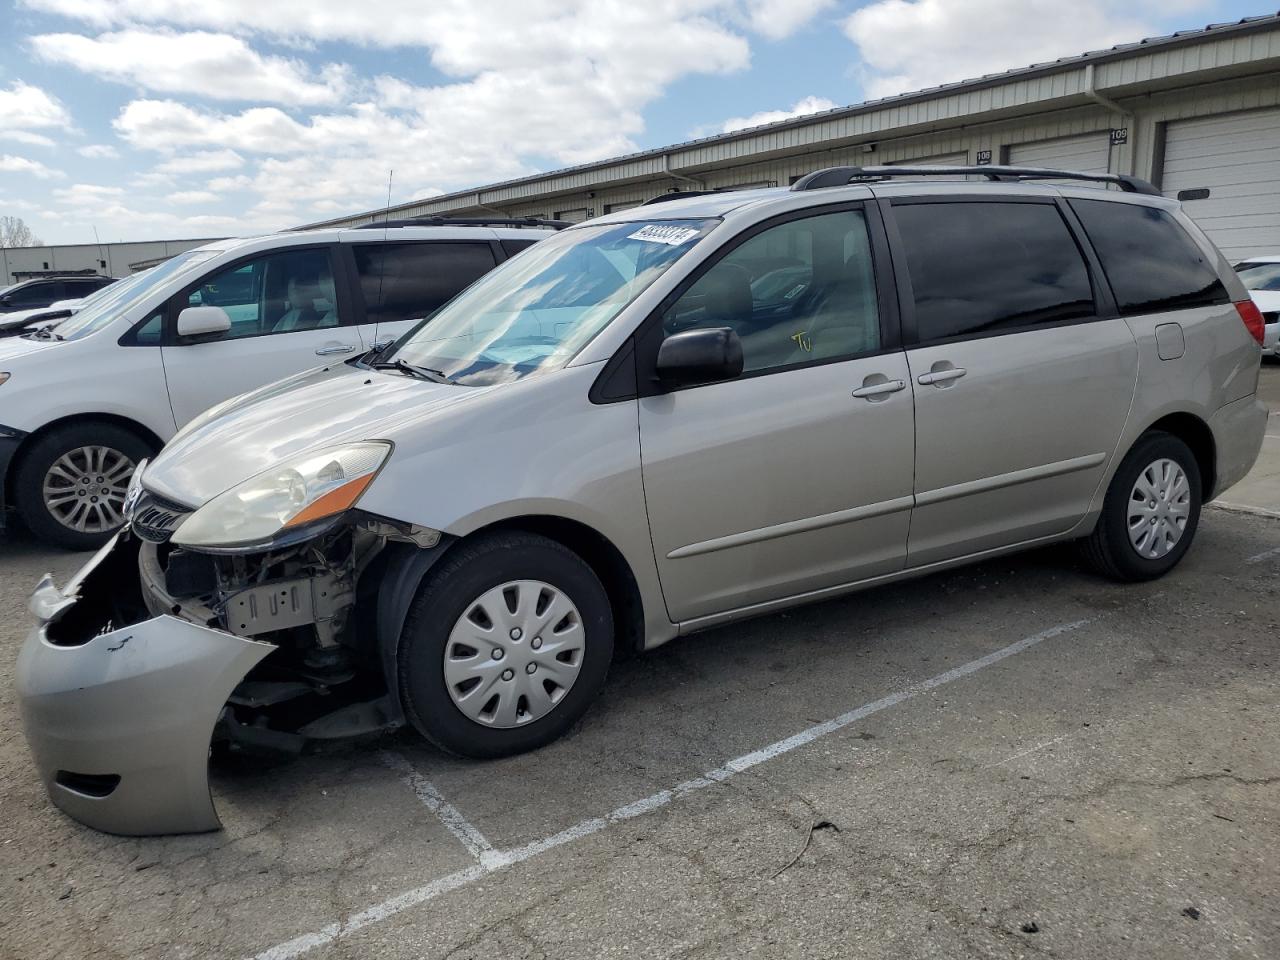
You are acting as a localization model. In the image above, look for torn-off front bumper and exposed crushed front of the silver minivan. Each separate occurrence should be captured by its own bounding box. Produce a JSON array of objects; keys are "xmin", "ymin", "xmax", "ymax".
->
[{"xmin": 17, "ymin": 513, "xmax": 439, "ymax": 835}]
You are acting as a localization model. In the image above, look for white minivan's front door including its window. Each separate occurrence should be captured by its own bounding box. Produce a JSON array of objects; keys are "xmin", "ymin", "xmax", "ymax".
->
[{"xmin": 161, "ymin": 244, "xmax": 369, "ymax": 428}]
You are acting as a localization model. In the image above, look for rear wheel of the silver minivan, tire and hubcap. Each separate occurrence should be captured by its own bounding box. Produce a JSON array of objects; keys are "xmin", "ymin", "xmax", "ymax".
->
[{"xmin": 1083, "ymin": 431, "xmax": 1202, "ymax": 581}]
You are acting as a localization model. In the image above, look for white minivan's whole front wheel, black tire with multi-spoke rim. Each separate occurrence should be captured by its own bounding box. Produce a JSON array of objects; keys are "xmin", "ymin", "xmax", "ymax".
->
[{"xmin": 13, "ymin": 422, "xmax": 155, "ymax": 550}]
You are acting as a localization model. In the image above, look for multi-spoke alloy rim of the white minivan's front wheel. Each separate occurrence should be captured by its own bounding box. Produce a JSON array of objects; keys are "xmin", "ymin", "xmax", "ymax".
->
[{"xmin": 44, "ymin": 447, "xmax": 136, "ymax": 534}]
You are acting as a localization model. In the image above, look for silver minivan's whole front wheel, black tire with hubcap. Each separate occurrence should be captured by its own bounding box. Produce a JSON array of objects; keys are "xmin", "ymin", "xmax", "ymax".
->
[{"xmin": 397, "ymin": 532, "xmax": 613, "ymax": 759}]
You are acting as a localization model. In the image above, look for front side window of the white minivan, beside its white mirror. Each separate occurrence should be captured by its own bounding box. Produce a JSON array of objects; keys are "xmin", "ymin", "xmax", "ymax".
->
[{"xmin": 185, "ymin": 250, "xmax": 338, "ymax": 340}]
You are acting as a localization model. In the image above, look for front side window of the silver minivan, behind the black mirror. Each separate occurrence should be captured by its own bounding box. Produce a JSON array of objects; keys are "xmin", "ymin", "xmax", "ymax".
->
[{"xmin": 663, "ymin": 210, "xmax": 881, "ymax": 372}]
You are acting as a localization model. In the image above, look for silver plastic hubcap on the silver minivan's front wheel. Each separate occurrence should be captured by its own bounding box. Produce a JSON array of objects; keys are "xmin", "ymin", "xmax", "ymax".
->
[{"xmin": 444, "ymin": 580, "xmax": 586, "ymax": 728}]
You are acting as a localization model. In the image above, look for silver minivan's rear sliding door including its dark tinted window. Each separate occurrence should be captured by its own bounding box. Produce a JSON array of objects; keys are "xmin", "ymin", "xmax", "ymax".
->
[{"xmin": 883, "ymin": 197, "xmax": 1138, "ymax": 567}]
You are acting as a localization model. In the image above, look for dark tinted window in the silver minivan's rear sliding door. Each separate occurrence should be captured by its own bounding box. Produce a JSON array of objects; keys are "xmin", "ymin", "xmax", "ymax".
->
[{"xmin": 893, "ymin": 202, "xmax": 1094, "ymax": 342}]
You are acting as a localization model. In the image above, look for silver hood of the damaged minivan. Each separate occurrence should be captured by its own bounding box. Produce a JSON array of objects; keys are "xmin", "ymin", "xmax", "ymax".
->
[{"xmin": 143, "ymin": 365, "xmax": 500, "ymax": 507}]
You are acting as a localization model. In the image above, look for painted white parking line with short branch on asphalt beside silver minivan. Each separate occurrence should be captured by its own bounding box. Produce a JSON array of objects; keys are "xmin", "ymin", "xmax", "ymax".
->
[{"xmin": 253, "ymin": 620, "xmax": 1089, "ymax": 960}]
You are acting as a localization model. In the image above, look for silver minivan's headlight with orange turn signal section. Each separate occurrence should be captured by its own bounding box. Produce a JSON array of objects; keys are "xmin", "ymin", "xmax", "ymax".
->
[{"xmin": 173, "ymin": 440, "xmax": 392, "ymax": 549}]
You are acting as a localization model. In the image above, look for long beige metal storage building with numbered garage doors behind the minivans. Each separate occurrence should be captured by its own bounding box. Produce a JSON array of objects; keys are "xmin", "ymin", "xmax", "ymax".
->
[{"xmin": 302, "ymin": 15, "xmax": 1280, "ymax": 259}]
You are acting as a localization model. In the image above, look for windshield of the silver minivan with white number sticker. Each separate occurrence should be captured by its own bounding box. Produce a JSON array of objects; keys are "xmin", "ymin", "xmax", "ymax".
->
[{"xmin": 384, "ymin": 220, "xmax": 718, "ymax": 387}]
